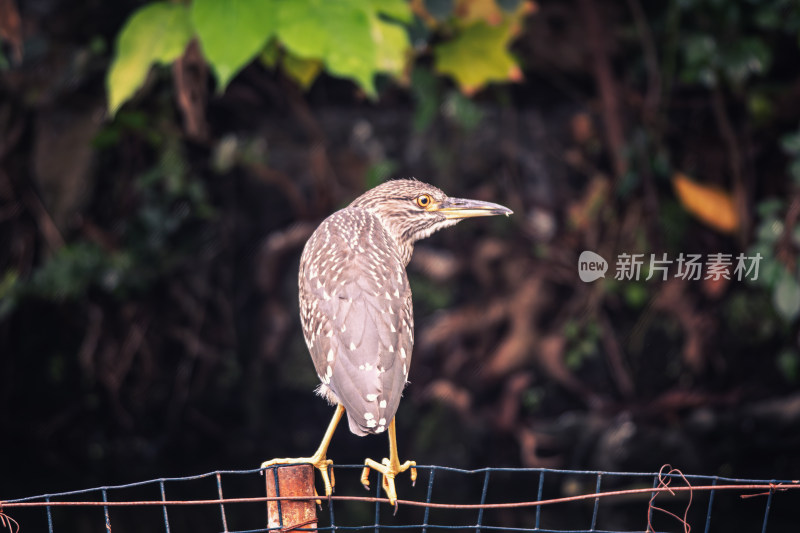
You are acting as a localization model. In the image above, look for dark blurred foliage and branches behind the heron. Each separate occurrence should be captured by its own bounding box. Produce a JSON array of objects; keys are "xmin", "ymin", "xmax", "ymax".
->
[{"xmin": 0, "ymin": 0, "xmax": 800, "ymax": 528}]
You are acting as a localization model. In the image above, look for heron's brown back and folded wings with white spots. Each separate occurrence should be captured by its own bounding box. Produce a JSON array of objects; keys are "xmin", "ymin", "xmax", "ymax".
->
[{"xmin": 300, "ymin": 209, "xmax": 413, "ymax": 435}]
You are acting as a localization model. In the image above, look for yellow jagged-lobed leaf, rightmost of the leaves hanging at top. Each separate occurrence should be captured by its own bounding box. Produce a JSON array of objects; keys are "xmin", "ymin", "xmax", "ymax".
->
[{"xmin": 434, "ymin": 22, "xmax": 522, "ymax": 95}]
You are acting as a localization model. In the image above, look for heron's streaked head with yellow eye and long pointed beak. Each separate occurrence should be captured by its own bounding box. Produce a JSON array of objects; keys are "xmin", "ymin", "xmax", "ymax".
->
[{"xmin": 350, "ymin": 179, "xmax": 512, "ymax": 247}]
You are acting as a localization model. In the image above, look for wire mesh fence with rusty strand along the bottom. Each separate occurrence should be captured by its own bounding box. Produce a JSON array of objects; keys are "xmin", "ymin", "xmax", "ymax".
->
[{"xmin": 0, "ymin": 465, "xmax": 800, "ymax": 533}]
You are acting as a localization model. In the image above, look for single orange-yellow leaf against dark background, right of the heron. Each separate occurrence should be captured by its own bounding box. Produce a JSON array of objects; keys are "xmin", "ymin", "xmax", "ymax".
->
[{"xmin": 672, "ymin": 172, "xmax": 739, "ymax": 233}]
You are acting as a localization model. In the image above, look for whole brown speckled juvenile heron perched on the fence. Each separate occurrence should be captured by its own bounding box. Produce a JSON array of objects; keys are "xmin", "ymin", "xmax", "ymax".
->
[{"xmin": 261, "ymin": 180, "xmax": 511, "ymax": 504}]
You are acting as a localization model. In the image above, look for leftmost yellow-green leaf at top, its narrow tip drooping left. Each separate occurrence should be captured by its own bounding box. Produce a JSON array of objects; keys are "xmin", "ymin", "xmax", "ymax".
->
[{"xmin": 106, "ymin": 2, "xmax": 192, "ymax": 115}]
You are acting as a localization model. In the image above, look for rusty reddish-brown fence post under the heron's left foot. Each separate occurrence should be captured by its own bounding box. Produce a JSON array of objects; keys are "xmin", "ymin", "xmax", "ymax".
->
[{"xmin": 264, "ymin": 464, "xmax": 317, "ymax": 532}]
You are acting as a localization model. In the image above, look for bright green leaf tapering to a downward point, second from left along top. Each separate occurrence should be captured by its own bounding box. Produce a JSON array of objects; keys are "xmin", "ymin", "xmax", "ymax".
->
[{"xmin": 191, "ymin": 0, "xmax": 277, "ymax": 92}]
